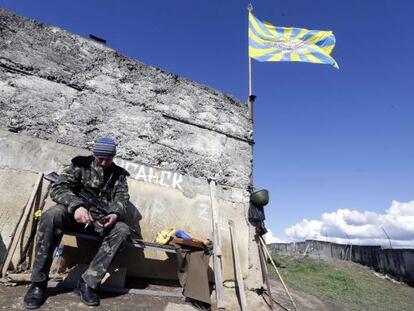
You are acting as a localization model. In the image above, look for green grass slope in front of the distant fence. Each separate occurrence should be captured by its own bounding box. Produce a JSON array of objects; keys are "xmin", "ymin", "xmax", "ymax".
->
[{"xmin": 269, "ymin": 254, "xmax": 414, "ymax": 311}]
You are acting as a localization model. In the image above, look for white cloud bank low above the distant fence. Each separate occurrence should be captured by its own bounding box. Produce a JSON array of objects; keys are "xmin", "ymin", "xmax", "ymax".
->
[{"xmin": 285, "ymin": 201, "xmax": 414, "ymax": 248}]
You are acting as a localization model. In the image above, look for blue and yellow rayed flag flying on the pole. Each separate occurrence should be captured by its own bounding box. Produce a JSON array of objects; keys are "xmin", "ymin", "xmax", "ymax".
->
[{"xmin": 249, "ymin": 12, "xmax": 339, "ymax": 68}]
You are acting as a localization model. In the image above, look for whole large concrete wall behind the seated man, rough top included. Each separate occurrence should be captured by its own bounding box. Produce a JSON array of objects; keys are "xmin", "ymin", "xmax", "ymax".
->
[{"xmin": 0, "ymin": 9, "xmax": 257, "ymax": 279}]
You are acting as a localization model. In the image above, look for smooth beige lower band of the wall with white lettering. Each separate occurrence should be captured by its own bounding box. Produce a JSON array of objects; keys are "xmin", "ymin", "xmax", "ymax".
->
[{"xmin": 0, "ymin": 130, "xmax": 249, "ymax": 279}]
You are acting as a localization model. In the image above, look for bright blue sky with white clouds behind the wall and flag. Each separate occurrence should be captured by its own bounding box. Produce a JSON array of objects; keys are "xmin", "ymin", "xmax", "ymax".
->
[{"xmin": 0, "ymin": 0, "xmax": 414, "ymax": 247}]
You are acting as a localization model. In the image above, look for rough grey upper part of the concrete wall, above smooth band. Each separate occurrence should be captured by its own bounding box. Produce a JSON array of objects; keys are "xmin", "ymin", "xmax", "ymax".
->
[{"xmin": 0, "ymin": 9, "xmax": 252, "ymax": 189}]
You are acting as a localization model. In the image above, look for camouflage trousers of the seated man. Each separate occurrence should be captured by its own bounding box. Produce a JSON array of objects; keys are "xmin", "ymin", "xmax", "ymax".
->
[{"xmin": 31, "ymin": 204, "xmax": 130, "ymax": 288}]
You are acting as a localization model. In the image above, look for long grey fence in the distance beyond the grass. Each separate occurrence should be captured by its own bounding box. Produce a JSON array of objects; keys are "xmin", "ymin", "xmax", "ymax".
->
[{"xmin": 268, "ymin": 240, "xmax": 414, "ymax": 286}]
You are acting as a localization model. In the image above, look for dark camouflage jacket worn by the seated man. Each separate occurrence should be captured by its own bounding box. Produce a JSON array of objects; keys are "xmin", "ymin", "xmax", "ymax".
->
[{"xmin": 50, "ymin": 156, "xmax": 129, "ymax": 220}]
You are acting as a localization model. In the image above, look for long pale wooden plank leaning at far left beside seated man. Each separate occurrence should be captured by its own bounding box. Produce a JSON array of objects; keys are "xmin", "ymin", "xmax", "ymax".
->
[{"xmin": 1, "ymin": 173, "xmax": 43, "ymax": 277}]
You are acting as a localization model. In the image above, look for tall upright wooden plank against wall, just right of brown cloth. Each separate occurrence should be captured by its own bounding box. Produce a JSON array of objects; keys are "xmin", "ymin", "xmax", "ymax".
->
[{"xmin": 209, "ymin": 179, "xmax": 225, "ymax": 310}]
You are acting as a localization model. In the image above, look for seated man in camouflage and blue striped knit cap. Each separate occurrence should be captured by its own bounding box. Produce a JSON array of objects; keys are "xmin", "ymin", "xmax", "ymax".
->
[{"xmin": 24, "ymin": 137, "xmax": 130, "ymax": 309}]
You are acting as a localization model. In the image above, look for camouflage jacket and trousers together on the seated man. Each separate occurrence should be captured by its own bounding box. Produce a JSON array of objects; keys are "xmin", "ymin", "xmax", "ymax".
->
[{"xmin": 32, "ymin": 156, "xmax": 130, "ymax": 288}]
